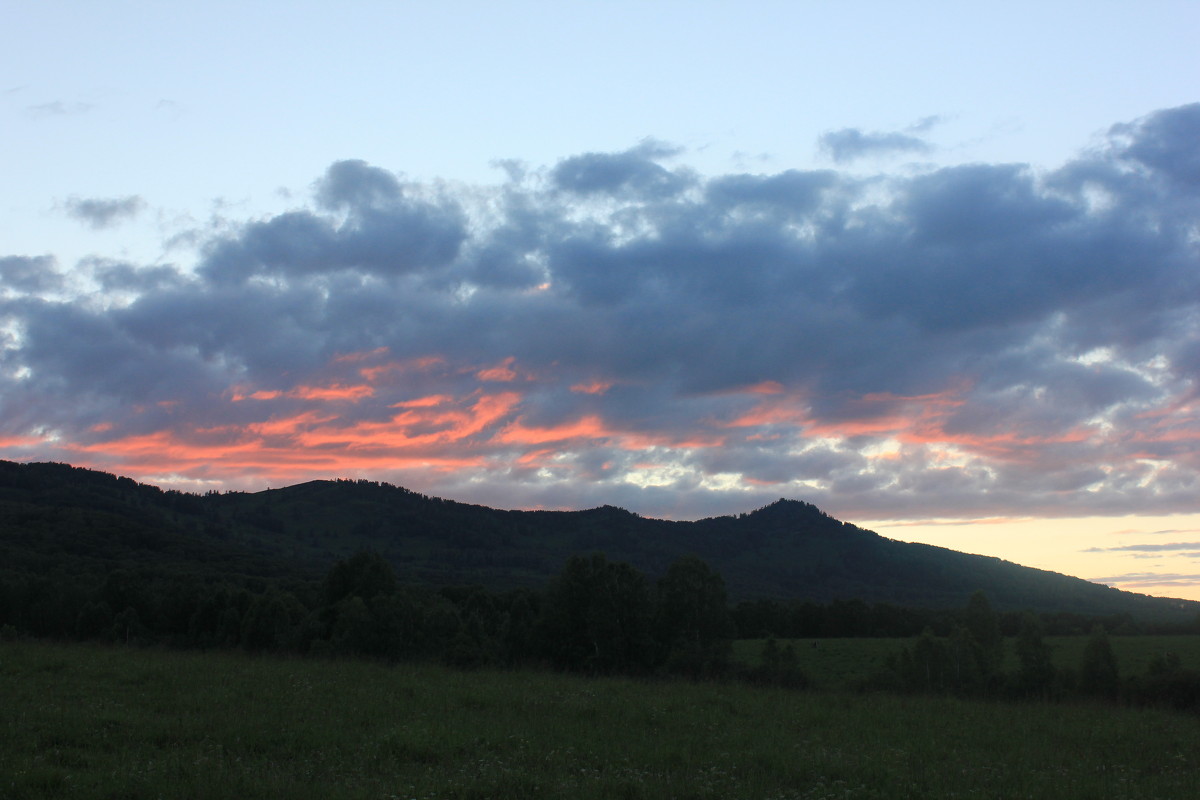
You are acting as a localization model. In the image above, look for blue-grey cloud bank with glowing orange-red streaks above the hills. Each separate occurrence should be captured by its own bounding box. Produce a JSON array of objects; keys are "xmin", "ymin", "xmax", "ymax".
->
[{"xmin": 0, "ymin": 104, "xmax": 1200, "ymax": 518}]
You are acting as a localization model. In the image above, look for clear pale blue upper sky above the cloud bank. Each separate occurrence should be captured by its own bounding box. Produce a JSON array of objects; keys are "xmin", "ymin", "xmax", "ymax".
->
[{"xmin": 9, "ymin": 0, "xmax": 1200, "ymax": 261}]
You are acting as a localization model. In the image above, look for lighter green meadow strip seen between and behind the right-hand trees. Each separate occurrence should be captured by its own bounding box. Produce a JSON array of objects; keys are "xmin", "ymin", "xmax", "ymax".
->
[{"xmin": 733, "ymin": 636, "xmax": 1200, "ymax": 688}]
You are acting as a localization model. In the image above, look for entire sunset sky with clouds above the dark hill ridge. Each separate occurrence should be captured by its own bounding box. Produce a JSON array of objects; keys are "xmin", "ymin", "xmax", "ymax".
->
[{"xmin": 0, "ymin": 0, "xmax": 1200, "ymax": 600}]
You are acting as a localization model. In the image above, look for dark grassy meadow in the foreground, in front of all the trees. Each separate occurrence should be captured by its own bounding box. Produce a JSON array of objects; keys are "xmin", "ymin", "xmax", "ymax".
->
[{"xmin": 7, "ymin": 642, "xmax": 1200, "ymax": 800}]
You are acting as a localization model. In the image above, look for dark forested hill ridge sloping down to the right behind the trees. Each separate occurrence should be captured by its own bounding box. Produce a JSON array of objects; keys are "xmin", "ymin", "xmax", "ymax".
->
[{"xmin": 0, "ymin": 462, "xmax": 1200, "ymax": 620}]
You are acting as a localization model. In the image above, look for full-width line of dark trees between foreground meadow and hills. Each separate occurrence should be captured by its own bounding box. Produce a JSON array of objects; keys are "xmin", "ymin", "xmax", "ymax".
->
[{"xmin": 0, "ymin": 551, "xmax": 1200, "ymax": 709}]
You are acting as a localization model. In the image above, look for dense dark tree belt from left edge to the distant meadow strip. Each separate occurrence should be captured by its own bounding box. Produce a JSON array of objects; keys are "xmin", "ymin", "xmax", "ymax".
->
[{"xmin": 0, "ymin": 551, "xmax": 737, "ymax": 675}]
